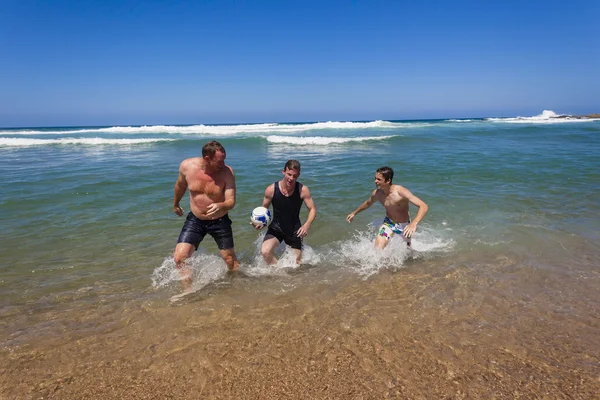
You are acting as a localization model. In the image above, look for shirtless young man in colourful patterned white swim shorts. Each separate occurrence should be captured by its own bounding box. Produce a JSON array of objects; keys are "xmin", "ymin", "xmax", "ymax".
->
[{"xmin": 346, "ymin": 167, "xmax": 429, "ymax": 248}]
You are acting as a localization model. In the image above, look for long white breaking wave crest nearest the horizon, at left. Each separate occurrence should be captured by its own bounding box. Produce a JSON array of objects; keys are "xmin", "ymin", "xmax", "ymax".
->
[{"xmin": 0, "ymin": 120, "xmax": 404, "ymax": 136}]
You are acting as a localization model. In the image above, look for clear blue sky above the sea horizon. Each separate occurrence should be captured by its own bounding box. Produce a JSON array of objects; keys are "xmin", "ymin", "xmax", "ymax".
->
[{"xmin": 0, "ymin": 0, "xmax": 600, "ymax": 127}]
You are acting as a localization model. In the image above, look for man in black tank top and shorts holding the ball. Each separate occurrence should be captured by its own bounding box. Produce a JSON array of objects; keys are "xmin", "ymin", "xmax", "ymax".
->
[{"xmin": 255, "ymin": 160, "xmax": 317, "ymax": 265}]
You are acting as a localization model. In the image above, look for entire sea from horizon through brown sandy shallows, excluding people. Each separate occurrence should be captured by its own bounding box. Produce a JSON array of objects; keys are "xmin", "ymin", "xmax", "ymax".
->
[{"xmin": 0, "ymin": 111, "xmax": 600, "ymax": 398}]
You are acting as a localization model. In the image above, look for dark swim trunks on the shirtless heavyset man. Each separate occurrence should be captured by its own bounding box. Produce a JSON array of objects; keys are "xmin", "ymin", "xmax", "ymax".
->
[{"xmin": 177, "ymin": 211, "xmax": 233, "ymax": 250}]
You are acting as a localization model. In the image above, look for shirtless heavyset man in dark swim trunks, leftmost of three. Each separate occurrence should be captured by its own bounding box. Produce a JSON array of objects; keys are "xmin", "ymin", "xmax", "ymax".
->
[{"xmin": 173, "ymin": 141, "xmax": 239, "ymax": 293}]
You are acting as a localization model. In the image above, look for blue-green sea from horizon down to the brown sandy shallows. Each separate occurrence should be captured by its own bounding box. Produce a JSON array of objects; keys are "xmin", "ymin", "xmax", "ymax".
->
[{"xmin": 0, "ymin": 111, "xmax": 600, "ymax": 322}]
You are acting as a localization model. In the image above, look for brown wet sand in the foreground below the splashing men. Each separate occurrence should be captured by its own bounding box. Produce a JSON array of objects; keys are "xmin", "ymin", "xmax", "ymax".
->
[{"xmin": 0, "ymin": 257, "xmax": 600, "ymax": 399}]
